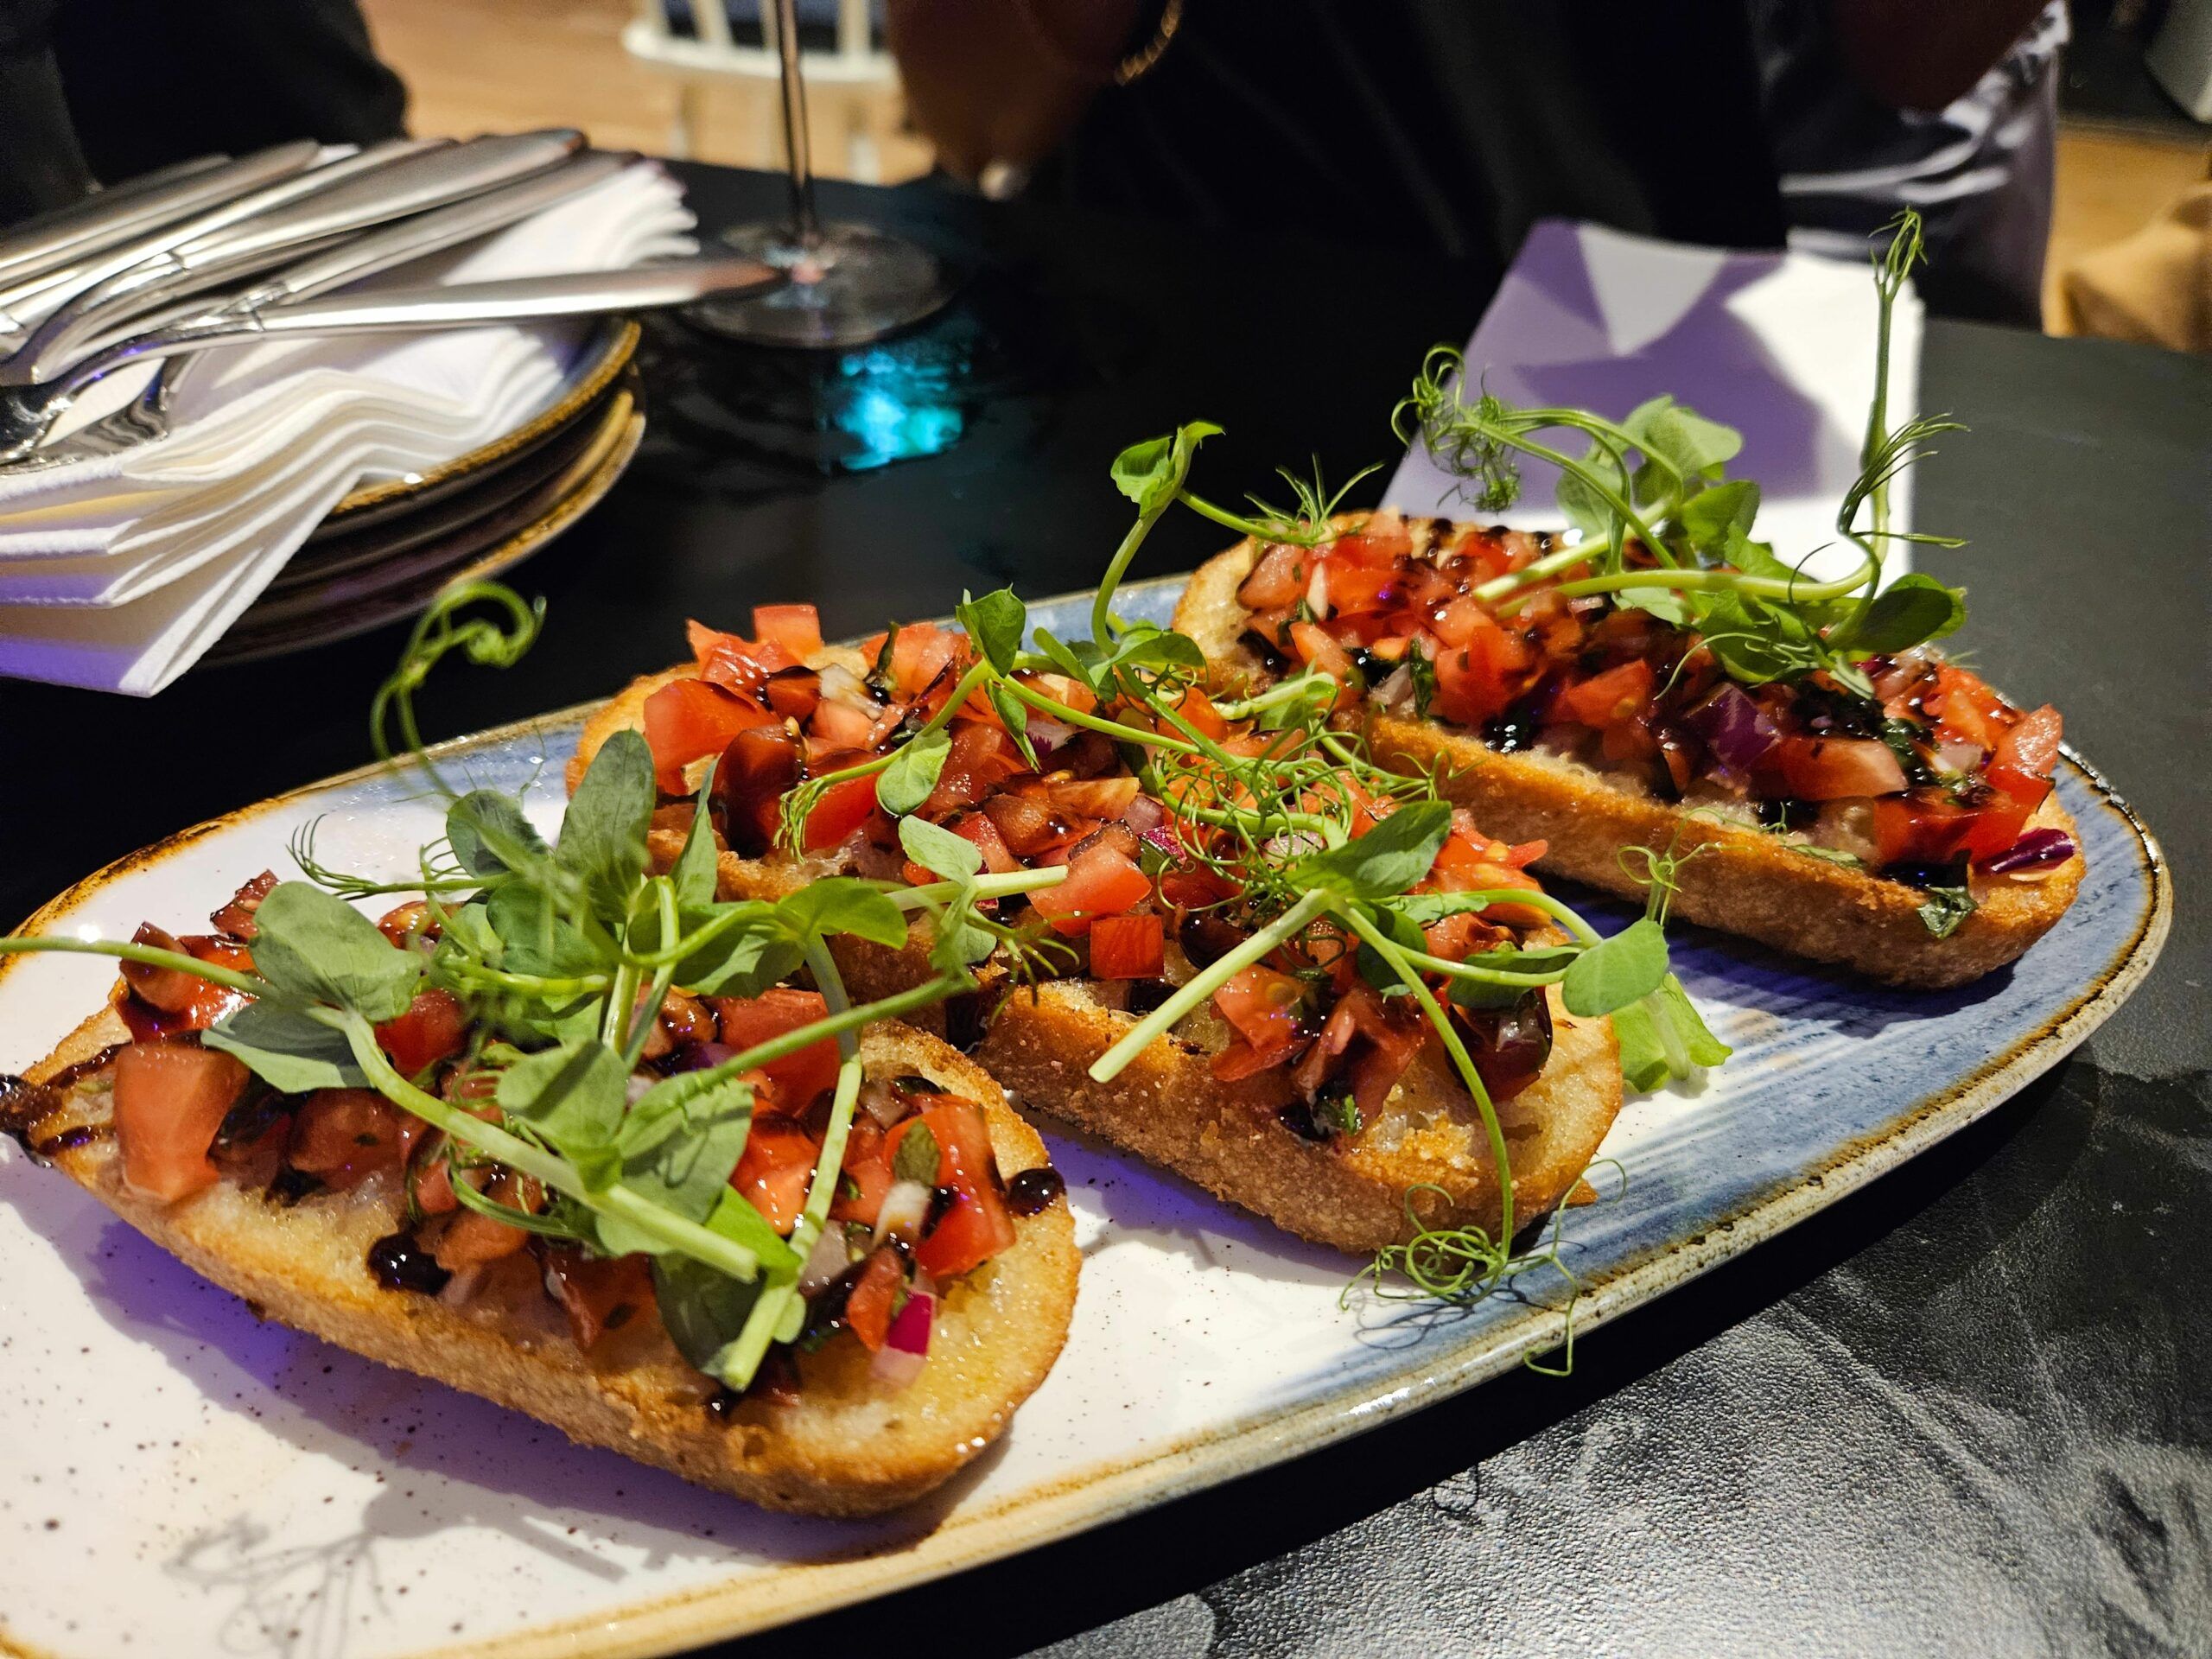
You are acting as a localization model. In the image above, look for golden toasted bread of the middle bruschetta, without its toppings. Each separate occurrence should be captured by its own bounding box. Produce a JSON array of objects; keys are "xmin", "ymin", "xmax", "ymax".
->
[{"xmin": 569, "ymin": 668, "xmax": 1621, "ymax": 1255}]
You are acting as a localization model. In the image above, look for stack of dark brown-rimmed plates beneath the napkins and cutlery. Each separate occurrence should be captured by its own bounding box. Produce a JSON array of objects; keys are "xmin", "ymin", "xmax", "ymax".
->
[{"xmin": 204, "ymin": 321, "xmax": 646, "ymax": 664}]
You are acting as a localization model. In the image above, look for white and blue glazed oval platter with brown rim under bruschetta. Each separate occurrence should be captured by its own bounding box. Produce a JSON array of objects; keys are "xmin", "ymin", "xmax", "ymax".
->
[{"xmin": 0, "ymin": 580, "xmax": 2172, "ymax": 1659}]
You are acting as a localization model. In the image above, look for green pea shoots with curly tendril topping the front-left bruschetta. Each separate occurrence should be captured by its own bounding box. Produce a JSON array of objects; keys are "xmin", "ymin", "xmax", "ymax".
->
[{"xmin": 0, "ymin": 582, "xmax": 1013, "ymax": 1389}]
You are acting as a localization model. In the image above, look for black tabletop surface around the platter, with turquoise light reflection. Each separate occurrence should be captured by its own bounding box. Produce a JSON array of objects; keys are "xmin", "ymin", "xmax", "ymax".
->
[{"xmin": 0, "ymin": 168, "xmax": 2212, "ymax": 1659}]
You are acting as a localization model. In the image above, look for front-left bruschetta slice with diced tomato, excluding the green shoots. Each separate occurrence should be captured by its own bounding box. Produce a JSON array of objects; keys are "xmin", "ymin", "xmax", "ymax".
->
[{"xmin": 0, "ymin": 876, "xmax": 1077, "ymax": 1516}]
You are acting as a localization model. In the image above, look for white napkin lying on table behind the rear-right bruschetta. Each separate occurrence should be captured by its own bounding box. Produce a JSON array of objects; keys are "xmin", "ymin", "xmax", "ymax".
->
[{"xmin": 1382, "ymin": 219, "xmax": 1923, "ymax": 575}]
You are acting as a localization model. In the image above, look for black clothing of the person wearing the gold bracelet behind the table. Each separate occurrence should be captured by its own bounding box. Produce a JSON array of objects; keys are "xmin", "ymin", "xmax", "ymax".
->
[{"xmin": 1035, "ymin": 0, "xmax": 1785, "ymax": 302}]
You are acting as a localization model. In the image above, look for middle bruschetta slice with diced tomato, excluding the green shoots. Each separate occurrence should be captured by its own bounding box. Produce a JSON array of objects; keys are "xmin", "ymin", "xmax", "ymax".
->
[{"xmin": 570, "ymin": 606, "xmax": 1621, "ymax": 1255}]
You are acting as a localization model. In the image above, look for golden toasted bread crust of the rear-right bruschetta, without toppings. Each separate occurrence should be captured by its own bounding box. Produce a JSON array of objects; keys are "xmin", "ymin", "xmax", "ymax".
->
[{"xmin": 1174, "ymin": 513, "xmax": 2086, "ymax": 988}]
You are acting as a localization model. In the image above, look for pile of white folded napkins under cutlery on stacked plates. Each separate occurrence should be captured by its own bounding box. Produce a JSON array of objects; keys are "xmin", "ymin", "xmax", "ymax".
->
[{"xmin": 0, "ymin": 162, "xmax": 695, "ymax": 696}]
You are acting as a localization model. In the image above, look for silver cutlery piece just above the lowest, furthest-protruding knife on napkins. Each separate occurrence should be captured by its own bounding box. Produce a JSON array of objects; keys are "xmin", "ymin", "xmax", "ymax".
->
[{"xmin": 48, "ymin": 150, "xmax": 637, "ymax": 467}]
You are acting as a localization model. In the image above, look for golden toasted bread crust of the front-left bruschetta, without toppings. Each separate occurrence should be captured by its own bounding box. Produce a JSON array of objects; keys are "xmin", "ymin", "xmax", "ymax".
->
[{"xmin": 11, "ymin": 1007, "xmax": 1079, "ymax": 1516}]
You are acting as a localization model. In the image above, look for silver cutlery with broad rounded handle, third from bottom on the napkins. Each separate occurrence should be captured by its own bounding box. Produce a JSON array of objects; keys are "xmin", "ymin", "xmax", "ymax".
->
[{"xmin": 0, "ymin": 130, "xmax": 584, "ymax": 385}]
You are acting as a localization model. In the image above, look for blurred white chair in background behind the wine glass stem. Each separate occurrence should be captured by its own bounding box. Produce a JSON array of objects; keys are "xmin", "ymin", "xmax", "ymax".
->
[{"xmin": 621, "ymin": 0, "xmax": 902, "ymax": 183}]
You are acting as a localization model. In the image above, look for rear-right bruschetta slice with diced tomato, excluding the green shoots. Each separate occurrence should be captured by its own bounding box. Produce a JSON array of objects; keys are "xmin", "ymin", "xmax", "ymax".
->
[{"xmin": 1174, "ymin": 511, "xmax": 2084, "ymax": 988}]
